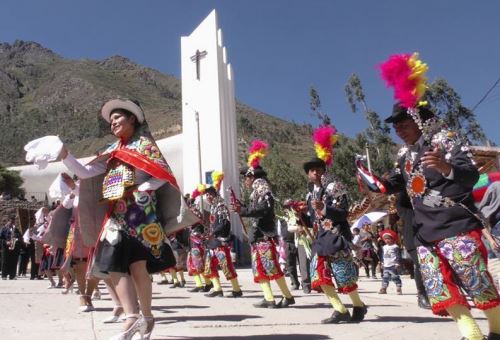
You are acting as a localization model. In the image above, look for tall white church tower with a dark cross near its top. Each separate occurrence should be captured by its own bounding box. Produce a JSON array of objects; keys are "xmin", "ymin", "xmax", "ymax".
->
[{"xmin": 181, "ymin": 10, "xmax": 241, "ymax": 236}]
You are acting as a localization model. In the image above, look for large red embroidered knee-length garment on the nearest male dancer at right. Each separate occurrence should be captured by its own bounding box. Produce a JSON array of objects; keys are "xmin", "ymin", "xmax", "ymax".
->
[{"xmin": 417, "ymin": 229, "xmax": 500, "ymax": 316}]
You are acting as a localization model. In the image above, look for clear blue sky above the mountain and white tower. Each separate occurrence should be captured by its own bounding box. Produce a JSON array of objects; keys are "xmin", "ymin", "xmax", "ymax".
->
[{"xmin": 0, "ymin": 0, "xmax": 500, "ymax": 144}]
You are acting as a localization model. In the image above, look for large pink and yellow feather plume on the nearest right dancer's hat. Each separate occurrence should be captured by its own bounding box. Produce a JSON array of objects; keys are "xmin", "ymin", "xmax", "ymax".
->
[{"xmin": 379, "ymin": 53, "xmax": 429, "ymax": 109}]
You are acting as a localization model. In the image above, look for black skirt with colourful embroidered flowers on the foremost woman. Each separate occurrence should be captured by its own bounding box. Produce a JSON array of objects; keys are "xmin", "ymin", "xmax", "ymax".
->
[{"xmin": 95, "ymin": 190, "xmax": 175, "ymax": 273}]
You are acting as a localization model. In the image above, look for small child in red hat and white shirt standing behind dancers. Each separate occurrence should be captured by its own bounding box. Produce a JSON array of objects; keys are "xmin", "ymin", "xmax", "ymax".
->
[{"xmin": 378, "ymin": 229, "xmax": 403, "ymax": 295}]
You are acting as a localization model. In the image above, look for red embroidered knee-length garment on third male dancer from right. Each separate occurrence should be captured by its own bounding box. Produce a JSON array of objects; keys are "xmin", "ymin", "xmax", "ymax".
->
[{"xmin": 251, "ymin": 239, "xmax": 284, "ymax": 283}]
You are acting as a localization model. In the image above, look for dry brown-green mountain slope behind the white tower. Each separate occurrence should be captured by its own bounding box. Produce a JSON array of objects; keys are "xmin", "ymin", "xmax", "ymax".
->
[{"xmin": 0, "ymin": 41, "xmax": 313, "ymax": 170}]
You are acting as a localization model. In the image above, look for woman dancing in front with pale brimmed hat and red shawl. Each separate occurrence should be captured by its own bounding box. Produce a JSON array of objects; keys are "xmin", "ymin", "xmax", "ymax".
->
[{"xmin": 61, "ymin": 99, "xmax": 196, "ymax": 339}]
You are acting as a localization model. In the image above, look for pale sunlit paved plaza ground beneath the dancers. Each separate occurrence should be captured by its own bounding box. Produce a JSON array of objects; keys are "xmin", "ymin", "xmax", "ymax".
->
[{"xmin": 0, "ymin": 260, "xmax": 500, "ymax": 340}]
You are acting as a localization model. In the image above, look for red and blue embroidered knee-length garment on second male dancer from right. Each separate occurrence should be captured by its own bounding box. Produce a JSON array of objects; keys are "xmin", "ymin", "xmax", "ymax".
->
[{"xmin": 311, "ymin": 250, "xmax": 358, "ymax": 294}]
